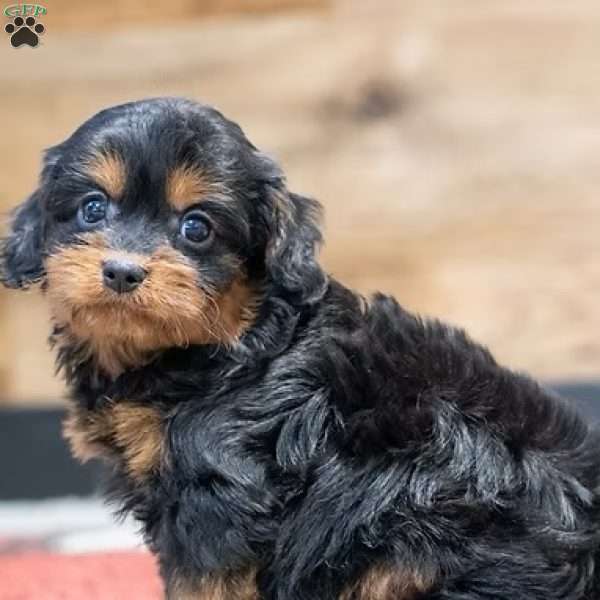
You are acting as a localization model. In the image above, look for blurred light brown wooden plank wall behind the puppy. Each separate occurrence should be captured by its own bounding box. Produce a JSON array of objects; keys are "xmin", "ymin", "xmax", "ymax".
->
[{"xmin": 0, "ymin": 0, "xmax": 600, "ymax": 402}]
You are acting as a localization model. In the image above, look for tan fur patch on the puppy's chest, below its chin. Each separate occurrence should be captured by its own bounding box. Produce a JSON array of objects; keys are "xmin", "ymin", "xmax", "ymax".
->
[{"xmin": 63, "ymin": 403, "xmax": 163, "ymax": 483}]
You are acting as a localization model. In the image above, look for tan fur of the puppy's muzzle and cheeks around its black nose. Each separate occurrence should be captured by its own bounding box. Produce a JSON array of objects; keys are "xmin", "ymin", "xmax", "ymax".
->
[{"xmin": 46, "ymin": 233, "xmax": 257, "ymax": 376}]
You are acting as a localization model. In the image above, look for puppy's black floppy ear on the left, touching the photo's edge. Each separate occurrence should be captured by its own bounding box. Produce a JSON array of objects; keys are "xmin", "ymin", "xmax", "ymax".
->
[{"xmin": 0, "ymin": 190, "xmax": 44, "ymax": 288}]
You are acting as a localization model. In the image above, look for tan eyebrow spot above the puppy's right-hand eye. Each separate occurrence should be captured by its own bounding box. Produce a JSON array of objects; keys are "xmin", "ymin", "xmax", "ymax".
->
[{"xmin": 165, "ymin": 165, "xmax": 225, "ymax": 212}]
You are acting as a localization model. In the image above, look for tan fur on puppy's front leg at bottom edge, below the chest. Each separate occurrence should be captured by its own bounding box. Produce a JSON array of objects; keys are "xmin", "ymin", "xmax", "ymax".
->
[{"xmin": 167, "ymin": 569, "xmax": 259, "ymax": 600}]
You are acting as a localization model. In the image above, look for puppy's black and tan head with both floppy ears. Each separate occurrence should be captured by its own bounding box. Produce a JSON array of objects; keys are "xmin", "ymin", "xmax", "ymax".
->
[{"xmin": 1, "ymin": 99, "xmax": 326, "ymax": 373}]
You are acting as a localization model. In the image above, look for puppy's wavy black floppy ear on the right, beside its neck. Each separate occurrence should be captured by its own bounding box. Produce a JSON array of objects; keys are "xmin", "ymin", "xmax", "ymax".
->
[{"xmin": 265, "ymin": 182, "xmax": 327, "ymax": 304}]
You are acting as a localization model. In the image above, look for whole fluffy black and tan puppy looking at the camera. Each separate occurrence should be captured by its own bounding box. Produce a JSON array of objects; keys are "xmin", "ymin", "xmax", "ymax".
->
[{"xmin": 3, "ymin": 99, "xmax": 600, "ymax": 600}]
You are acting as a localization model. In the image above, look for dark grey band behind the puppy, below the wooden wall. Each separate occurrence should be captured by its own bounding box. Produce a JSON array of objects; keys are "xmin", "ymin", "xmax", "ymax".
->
[{"xmin": 0, "ymin": 382, "xmax": 600, "ymax": 500}]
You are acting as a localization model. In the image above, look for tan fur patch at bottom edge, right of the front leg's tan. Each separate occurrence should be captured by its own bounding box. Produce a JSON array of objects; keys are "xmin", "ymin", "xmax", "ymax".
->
[{"xmin": 338, "ymin": 566, "xmax": 433, "ymax": 600}]
